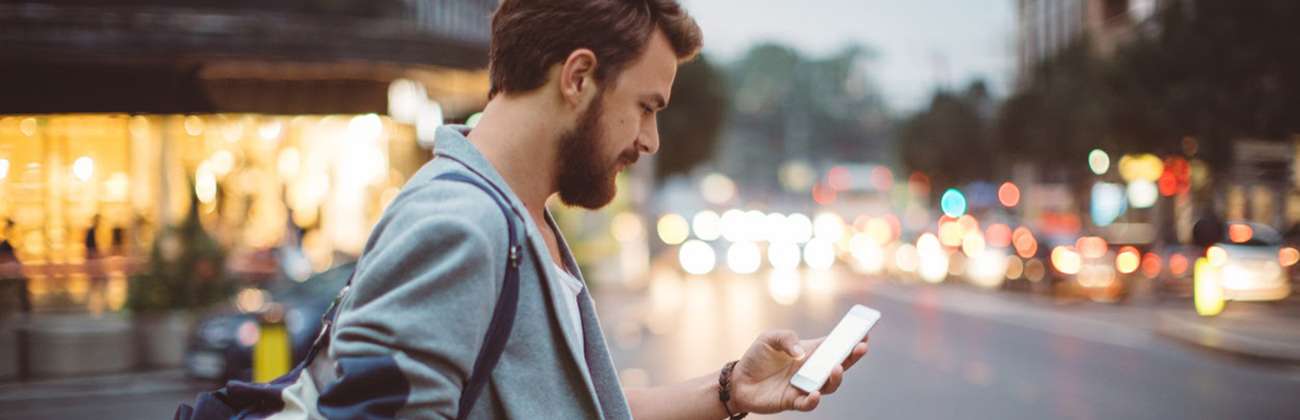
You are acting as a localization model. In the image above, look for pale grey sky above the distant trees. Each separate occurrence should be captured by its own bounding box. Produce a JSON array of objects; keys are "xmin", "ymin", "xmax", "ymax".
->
[{"xmin": 683, "ymin": 0, "xmax": 1015, "ymax": 113}]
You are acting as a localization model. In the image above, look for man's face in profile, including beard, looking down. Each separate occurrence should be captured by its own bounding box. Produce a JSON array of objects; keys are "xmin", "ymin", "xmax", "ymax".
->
[{"xmin": 556, "ymin": 30, "xmax": 677, "ymax": 209}]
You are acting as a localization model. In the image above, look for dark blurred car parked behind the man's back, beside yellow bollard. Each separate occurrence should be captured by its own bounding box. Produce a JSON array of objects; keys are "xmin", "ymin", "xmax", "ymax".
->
[{"xmin": 185, "ymin": 263, "xmax": 355, "ymax": 381}]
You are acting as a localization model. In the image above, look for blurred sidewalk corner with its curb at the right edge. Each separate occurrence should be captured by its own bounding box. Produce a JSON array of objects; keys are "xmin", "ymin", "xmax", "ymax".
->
[{"xmin": 1156, "ymin": 298, "xmax": 1300, "ymax": 363}]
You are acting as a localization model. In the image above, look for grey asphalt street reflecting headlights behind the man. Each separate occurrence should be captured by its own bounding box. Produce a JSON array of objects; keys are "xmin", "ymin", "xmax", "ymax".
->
[{"xmin": 0, "ymin": 269, "xmax": 1300, "ymax": 419}]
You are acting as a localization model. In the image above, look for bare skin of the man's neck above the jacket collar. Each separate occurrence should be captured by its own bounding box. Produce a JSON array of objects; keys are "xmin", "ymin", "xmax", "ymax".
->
[{"xmin": 469, "ymin": 94, "xmax": 560, "ymax": 222}]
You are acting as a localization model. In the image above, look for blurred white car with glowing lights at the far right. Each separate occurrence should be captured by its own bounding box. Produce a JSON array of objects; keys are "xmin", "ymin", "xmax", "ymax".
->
[{"xmin": 1205, "ymin": 222, "xmax": 1291, "ymax": 300}]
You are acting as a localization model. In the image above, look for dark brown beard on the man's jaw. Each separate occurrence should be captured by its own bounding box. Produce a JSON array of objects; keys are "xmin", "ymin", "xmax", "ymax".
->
[{"xmin": 555, "ymin": 94, "xmax": 640, "ymax": 209}]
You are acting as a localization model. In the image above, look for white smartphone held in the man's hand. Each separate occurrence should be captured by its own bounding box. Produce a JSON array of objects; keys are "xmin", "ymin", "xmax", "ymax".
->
[{"xmin": 790, "ymin": 304, "xmax": 880, "ymax": 394}]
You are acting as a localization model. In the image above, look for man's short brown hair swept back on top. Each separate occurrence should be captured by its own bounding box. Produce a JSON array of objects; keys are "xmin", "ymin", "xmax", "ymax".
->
[{"xmin": 488, "ymin": 0, "xmax": 703, "ymax": 98}]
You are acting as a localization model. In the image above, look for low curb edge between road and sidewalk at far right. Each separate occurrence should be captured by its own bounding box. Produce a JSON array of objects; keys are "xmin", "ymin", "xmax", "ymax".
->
[{"xmin": 1156, "ymin": 313, "xmax": 1300, "ymax": 364}]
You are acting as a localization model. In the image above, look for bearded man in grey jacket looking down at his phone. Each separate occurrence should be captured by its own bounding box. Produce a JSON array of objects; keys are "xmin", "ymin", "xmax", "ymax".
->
[{"xmin": 313, "ymin": 0, "xmax": 867, "ymax": 419}]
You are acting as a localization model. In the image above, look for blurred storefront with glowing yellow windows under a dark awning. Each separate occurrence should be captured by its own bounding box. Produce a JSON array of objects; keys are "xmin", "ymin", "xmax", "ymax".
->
[{"xmin": 0, "ymin": 0, "xmax": 495, "ymax": 313}]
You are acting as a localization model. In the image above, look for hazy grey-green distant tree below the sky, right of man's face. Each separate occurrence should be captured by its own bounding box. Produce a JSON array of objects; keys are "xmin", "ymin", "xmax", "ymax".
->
[{"xmin": 723, "ymin": 43, "xmax": 892, "ymax": 190}]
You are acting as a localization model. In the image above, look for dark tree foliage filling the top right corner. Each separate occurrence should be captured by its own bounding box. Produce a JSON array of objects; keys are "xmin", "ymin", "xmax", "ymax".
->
[{"xmin": 1113, "ymin": 0, "xmax": 1300, "ymax": 169}]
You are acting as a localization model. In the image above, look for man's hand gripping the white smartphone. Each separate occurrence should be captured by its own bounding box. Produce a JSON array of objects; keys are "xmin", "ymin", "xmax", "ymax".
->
[{"xmin": 731, "ymin": 330, "xmax": 867, "ymax": 413}]
